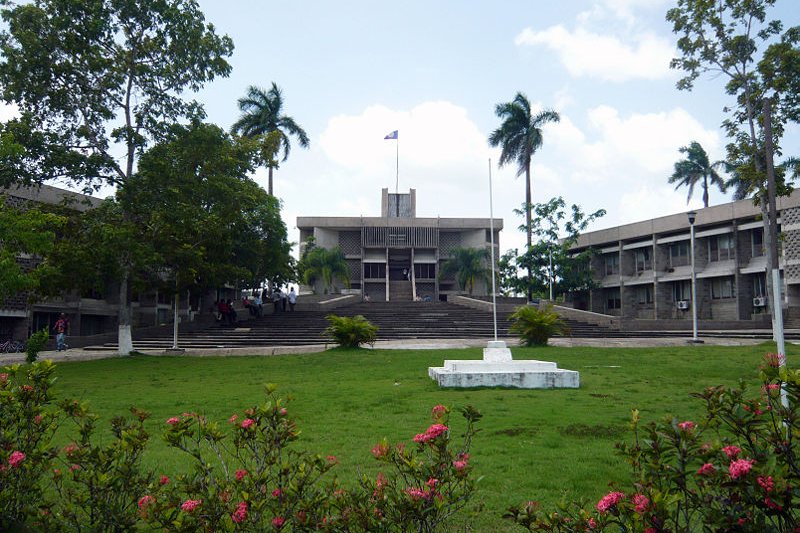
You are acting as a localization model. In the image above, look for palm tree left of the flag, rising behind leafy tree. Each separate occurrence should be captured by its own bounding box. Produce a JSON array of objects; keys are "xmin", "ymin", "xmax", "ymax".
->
[{"xmin": 231, "ymin": 82, "xmax": 310, "ymax": 195}]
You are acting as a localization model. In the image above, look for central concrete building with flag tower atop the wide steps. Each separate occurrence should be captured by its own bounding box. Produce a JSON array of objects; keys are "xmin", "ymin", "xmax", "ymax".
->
[{"xmin": 297, "ymin": 189, "xmax": 503, "ymax": 301}]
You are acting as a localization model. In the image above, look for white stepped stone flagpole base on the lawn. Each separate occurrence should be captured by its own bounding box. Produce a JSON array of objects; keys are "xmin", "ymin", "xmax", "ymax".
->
[{"xmin": 428, "ymin": 341, "xmax": 580, "ymax": 389}]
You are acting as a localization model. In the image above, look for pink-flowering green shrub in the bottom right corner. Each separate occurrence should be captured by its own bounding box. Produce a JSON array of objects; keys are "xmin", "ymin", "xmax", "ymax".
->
[{"xmin": 506, "ymin": 354, "xmax": 800, "ymax": 533}]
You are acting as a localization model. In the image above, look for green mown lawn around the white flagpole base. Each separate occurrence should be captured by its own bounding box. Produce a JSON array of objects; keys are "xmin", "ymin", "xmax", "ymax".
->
[{"xmin": 37, "ymin": 345, "xmax": 799, "ymax": 531}]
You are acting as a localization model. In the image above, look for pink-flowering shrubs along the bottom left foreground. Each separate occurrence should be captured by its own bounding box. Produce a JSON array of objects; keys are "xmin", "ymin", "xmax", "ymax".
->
[{"xmin": 0, "ymin": 361, "xmax": 481, "ymax": 532}]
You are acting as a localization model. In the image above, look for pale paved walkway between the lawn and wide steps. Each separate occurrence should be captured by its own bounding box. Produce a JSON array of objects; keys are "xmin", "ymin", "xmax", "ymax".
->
[{"xmin": 0, "ymin": 336, "xmax": 776, "ymax": 366}]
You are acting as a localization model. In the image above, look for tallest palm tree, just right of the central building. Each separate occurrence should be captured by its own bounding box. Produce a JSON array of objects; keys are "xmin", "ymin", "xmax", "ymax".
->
[{"xmin": 489, "ymin": 92, "xmax": 561, "ymax": 300}]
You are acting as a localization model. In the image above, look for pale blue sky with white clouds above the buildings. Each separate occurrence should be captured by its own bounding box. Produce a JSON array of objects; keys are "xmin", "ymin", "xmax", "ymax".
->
[{"xmin": 4, "ymin": 0, "xmax": 800, "ymax": 258}]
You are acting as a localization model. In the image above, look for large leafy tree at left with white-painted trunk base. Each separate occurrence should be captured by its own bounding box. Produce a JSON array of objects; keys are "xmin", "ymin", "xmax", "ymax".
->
[{"xmin": 0, "ymin": 0, "xmax": 233, "ymax": 354}]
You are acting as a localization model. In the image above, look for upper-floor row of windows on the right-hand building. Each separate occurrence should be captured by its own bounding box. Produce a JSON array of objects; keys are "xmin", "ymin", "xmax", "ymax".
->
[{"xmin": 604, "ymin": 228, "xmax": 764, "ymax": 276}]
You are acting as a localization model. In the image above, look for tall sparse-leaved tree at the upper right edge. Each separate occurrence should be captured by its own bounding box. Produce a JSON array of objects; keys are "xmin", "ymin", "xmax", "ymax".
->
[{"xmin": 667, "ymin": 0, "xmax": 800, "ymax": 316}]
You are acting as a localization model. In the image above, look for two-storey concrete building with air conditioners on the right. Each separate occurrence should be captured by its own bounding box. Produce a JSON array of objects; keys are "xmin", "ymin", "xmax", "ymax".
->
[{"xmin": 572, "ymin": 191, "xmax": 800, "ymax": 328}]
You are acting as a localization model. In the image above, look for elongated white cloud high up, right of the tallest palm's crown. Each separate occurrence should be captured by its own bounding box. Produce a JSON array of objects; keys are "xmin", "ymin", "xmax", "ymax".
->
[{"xmin": 514, "ymin": 24, "xmax": 674, "ymax": 82}]
